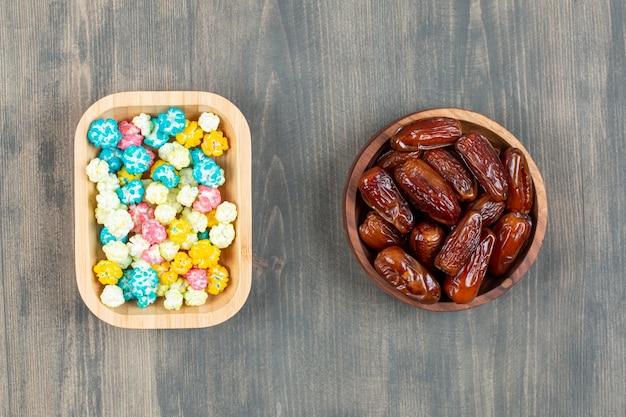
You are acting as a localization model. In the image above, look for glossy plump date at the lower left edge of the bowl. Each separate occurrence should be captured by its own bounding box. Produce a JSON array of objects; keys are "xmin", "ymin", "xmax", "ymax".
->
[{"xmin": 374, "ymin": 246, "xmax": 441, "ymax": 304}]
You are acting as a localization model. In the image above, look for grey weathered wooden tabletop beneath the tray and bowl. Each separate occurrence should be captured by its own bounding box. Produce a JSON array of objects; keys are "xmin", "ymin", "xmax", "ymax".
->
[{"xmin": 0, "ymin": 0, "xmax": 626, "ymax": 417}]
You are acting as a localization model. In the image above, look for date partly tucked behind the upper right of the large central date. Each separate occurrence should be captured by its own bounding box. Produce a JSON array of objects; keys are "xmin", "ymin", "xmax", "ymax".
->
[{"xmin": 422, "ymin": 148, "xmax": 478, "ymax": 202}]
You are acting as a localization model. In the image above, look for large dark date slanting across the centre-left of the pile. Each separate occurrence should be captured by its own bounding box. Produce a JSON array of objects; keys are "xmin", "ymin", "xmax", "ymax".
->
[{"xmin": 394, "ymin": 159, "xmax": 461, "ymax": 226}]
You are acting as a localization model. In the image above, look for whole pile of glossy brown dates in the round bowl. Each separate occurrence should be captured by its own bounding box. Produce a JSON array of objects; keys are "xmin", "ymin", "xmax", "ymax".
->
[{"xmin": 359, "ymin": 117, "xmax": 534, "ymax": 304}]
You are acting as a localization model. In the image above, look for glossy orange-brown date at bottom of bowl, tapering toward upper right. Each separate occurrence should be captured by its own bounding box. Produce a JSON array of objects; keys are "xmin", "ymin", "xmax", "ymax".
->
[{"xmin": 443, "ymin": 229, "xmax": 496, "ymax": 304}]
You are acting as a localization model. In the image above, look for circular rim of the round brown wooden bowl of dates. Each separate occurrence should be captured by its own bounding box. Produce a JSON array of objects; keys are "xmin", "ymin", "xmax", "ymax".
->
[{"xmin": 341, "ymin": 107, "xmax": 548, "ymax": 312}]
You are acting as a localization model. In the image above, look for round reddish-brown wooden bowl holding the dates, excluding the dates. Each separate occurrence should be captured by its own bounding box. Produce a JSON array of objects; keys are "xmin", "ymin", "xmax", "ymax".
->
[{"xmin": 342, "ymin": 108, "xmax": 548, "ymax": 311}]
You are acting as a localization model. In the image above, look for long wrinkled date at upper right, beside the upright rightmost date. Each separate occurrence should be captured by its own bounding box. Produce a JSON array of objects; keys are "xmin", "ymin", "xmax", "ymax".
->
[{"xmin": 455, "ymin": 131, "xmax": 508, "ymax": 201}]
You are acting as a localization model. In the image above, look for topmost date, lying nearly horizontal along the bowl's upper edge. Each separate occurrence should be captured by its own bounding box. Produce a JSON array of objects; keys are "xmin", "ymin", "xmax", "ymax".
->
[{"xmin": 389, "ymin": 117, "xmax": 462, "ymax": 151}]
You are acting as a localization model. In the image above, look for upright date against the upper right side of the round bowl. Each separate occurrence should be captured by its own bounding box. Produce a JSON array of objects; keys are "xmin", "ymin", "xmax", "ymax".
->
[{"xmin": 501, "ymin": 148, "xmax": 535, "ymax": 214}]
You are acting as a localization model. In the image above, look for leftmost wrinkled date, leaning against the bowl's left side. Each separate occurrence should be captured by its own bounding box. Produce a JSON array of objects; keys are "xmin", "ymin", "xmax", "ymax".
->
[{"xmin": 359, "ymin": 167, "xmax": 415, "ymax": 233}]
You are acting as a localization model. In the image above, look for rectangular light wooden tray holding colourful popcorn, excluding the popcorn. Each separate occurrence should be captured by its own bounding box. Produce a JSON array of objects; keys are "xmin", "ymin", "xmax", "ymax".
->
[{"xmin": 74, "ymin": 91, "xmax": 252, "ymax": 329}]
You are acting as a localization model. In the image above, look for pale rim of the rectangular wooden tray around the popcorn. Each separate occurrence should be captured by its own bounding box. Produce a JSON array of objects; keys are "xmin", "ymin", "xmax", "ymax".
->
[{"xmin": 73, "ymin": 91, "xmax": 252, "ymax": 329}]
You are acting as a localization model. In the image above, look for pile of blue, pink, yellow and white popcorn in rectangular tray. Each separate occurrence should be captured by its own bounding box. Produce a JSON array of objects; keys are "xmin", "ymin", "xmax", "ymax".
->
[{"xmin": 87, "ymin": 107, "xmax": 237, "ymax": 310}]
